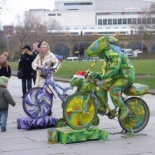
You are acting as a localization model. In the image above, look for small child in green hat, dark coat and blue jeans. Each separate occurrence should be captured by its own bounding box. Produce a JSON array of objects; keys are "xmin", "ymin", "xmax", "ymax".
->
[{"xmin": 0, "ymin": 76, "xmax": 16, "ymax": 132}]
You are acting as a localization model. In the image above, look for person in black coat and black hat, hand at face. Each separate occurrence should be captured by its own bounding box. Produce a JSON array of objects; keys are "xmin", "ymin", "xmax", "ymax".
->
[{"xmin": 18, "ymin": 45, "xmax": 34, "ymax": 98}]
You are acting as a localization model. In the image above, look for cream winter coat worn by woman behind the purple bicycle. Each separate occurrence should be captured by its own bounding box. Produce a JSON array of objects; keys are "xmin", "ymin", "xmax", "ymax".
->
[{"xmin": 32, "ymin": 51, "xmax": 60, "ymax": 87}]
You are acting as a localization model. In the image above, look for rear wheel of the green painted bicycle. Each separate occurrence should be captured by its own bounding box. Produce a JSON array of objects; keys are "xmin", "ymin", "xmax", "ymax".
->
[{"xmin": 119, "ymin": 97, "xmax": 150, "ymax": 133}]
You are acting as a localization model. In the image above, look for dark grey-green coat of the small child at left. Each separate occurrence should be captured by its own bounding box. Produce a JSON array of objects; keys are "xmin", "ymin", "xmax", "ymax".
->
[{"xmin": 0, "ymin": 84, "xmax": 16, "ymax": 110}]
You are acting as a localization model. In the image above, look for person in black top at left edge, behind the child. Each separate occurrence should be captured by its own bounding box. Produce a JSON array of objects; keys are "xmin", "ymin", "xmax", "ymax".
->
[{"xmin": 0, "ymin": 54, "xmax": 11, "ymax": 78}]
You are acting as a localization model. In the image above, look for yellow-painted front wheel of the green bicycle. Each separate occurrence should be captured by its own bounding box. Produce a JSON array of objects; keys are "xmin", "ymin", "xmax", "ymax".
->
[{"xmin": 63, "ymin": 93, "xmax": 97, "ymax": 129}]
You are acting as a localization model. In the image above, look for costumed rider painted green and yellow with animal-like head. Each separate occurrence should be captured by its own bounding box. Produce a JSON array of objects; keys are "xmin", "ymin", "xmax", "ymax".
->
[{"xmin": 87, "ymin": 36, "xmax": 135, "ymax": 120}]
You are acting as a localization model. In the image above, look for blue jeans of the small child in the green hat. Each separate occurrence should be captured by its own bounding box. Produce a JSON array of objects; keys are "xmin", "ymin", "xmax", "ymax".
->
[{"xmin": 0, "ymin": 110, "xmax": 8, "ymax": 129}]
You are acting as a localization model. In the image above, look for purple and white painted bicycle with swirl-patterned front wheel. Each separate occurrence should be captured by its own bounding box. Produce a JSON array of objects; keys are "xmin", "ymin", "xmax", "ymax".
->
[{"xmin": 22, "ymin": 67, "xmax": 73, "ymax": 119}]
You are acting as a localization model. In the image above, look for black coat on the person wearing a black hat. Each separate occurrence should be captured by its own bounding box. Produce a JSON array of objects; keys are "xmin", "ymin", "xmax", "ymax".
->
[{"xmin": 18, "ymin": 52, "xmax": 34, "ymax": 79}]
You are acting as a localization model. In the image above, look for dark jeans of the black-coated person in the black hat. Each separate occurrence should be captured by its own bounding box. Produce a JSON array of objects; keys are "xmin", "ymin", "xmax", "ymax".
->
[{"xmin": 22, "ymin": 78, "xmax": 32, "ymax": 96}]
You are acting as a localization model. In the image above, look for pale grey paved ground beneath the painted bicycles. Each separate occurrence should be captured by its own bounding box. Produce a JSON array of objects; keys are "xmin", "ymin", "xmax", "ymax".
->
[{"xmin": 0, "ymin": 76, "xmax": 155, "ymax": 155}]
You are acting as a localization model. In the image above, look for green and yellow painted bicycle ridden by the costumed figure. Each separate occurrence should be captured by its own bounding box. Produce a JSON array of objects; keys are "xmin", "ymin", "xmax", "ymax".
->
[{"xmin": 63, "ymin": 62, "xmax": 150, "ymax": 133}]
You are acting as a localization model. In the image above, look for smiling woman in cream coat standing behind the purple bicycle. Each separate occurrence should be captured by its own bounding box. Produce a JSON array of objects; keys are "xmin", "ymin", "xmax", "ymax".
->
[{"xmin": 32, "ymin": 41, "xmax": 60, "ymax": 115}]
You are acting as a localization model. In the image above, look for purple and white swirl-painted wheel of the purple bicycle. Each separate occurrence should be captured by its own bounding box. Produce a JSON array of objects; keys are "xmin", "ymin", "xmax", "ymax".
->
[{"xmin": 23, "ymin": 87, "xmax": 53, "ymax": 119}]
